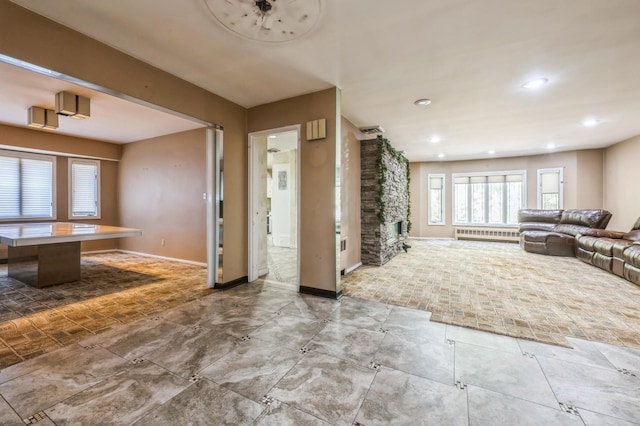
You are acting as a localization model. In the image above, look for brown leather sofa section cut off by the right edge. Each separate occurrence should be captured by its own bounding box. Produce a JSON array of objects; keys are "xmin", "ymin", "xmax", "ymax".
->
[{"xmin": 576, "ymin": 218, "xmax": 640, "ymax": 284}]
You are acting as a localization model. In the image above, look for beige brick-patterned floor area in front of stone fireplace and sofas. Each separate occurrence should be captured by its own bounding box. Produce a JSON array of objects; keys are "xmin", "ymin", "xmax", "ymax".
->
[{"xmin": 342, "ymin": 240, "xmax": 640, "ymax": 348}]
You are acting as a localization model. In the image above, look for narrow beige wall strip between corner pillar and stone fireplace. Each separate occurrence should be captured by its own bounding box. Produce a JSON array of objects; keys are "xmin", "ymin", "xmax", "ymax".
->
[{"xmin": 340, "ymin": 117, "xmax": 361, "ymax": 270}]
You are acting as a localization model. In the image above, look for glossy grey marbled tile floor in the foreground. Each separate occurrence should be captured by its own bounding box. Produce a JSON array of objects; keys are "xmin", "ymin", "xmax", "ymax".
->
[{"xmin": 0, "ymin": 284, "xmax": 640, "ymax": 426}]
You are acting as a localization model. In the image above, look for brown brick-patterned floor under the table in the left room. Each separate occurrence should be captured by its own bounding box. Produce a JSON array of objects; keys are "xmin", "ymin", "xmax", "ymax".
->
[{"xmin": 0, "ymin": 253, "xmax": 217, "ymax": 368}]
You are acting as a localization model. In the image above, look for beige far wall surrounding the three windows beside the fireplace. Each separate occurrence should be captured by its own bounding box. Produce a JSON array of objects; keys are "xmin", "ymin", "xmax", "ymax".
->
[{"xmin": 410, "ymin": 151, "xmax": 584, "ymax": 238}]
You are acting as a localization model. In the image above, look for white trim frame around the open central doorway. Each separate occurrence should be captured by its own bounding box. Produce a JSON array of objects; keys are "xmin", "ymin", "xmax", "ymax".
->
[{"xmin": 247, "ymin": 124, "xmax": 302, "ymax": 290}]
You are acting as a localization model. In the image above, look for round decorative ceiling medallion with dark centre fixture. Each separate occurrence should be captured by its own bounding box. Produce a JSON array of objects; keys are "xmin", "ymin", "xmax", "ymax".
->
[{"xmin": 204, "ymin": 0, "xmax": 321, "ymax": 43}]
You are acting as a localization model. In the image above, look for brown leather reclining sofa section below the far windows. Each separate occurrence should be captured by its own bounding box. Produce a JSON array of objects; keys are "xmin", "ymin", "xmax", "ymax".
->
[{"xmin": 518, "ymin": 209, "xmax": 611, "ymax": 256}]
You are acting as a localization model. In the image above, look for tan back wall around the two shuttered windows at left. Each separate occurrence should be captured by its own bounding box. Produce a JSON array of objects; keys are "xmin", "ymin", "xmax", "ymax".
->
[{"xmin": 0, "ymin": 124, "xmax": 120, "ymax": 259}]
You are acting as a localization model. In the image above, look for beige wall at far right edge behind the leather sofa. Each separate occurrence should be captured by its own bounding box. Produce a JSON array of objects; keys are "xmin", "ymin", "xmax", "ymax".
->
[{"xmin": 604, "ymin": 136, "xmax": 640, "ymax": 231}]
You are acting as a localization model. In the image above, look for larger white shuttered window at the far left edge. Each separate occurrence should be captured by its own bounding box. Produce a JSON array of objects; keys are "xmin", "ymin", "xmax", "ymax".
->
[{"xmin": 0, "ymin": 150, "xmax": 56, "ymax": 221}]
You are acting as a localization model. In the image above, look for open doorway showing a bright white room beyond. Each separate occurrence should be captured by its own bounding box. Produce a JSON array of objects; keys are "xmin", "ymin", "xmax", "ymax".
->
[{"xmin": 248, "ymin": 126, "xmax": 300, "ymax": 291}]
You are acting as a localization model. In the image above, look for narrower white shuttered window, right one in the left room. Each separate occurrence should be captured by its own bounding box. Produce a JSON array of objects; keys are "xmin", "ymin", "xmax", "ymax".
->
[{"xmin": 69, "ymin": 159, "xmax": 100, "ymax": 219}]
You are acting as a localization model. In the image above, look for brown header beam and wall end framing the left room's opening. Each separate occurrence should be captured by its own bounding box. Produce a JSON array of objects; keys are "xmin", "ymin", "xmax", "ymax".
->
[{"xmin": 0, "ymin": 1, "xmax": 247, "ymax": 281}]
